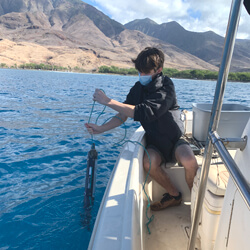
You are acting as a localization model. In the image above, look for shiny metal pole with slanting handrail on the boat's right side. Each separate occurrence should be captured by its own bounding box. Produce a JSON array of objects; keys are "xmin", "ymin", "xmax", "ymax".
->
[{"xmin": 188, "ymin": 0, "xmax": 246, "ymax": 250}]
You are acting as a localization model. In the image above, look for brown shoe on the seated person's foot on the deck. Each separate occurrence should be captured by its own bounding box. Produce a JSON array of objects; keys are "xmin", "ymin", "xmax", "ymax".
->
[{"xmin": 150, "ymin": 192, "xmax": 182, "ymax": 211}]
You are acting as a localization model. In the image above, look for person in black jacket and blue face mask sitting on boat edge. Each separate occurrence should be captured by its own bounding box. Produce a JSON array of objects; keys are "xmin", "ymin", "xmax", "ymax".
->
[{"xmin": 85, "ymin": 47, "xmax": 198, "ymax": 211}]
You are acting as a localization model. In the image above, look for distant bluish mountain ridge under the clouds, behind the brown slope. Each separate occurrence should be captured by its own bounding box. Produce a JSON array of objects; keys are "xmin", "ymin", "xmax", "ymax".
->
[{"xmin": 124, "ymin": 18, "xmax": 250, "ymax": 71}]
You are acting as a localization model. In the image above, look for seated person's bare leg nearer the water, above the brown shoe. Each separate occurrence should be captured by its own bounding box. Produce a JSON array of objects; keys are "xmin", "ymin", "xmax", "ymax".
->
[{"xmin": 143, "ymin": 148, "xmax": 179, "ymax": 196}]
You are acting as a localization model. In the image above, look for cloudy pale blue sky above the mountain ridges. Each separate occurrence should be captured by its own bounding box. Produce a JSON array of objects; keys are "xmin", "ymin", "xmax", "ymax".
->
[{"xmin": 84, "ymin": 0, "xmax": 250, "ymax": 39}]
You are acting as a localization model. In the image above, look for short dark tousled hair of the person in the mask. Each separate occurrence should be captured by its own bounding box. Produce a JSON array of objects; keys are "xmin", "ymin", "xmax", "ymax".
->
[{"xmin": 132, "ymin": 47, "xmax": 164, "ymax": 73}]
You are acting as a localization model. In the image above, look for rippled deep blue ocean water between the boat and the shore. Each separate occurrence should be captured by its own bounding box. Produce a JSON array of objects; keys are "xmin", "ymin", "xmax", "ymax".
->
[{"xmin": 0, "ymin": 69, "xmax": 250, "ymax": 249}]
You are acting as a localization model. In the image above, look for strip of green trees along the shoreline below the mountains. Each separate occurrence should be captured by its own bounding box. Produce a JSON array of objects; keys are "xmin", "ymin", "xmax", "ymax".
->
[{"xmin": 0, "ymin": 63, "xmax": 250, "ymax": 82}]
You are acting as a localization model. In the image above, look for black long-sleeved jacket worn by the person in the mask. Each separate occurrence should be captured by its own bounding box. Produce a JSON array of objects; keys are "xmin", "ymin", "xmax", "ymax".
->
[{"xmin": 124, "ymin": 73, "xmax": 182, "ymax": 160}]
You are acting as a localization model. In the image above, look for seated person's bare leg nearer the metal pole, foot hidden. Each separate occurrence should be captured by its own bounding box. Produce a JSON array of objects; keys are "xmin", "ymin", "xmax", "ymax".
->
[{"xmin": 175, "ymin": 144, "xmax": 198, "ymax": 190}]
